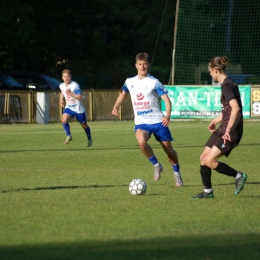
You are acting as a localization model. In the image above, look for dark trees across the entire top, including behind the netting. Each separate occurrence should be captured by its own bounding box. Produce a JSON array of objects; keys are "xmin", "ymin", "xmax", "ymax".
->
[{"xmin": 0, "ymin": 0, "xmax": 260, "ymax": 87}]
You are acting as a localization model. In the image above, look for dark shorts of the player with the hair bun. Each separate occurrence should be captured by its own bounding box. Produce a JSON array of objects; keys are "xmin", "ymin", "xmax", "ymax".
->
[{"xmin": 205, "ymin": 130, "xmax": 242, "ymax": 157}]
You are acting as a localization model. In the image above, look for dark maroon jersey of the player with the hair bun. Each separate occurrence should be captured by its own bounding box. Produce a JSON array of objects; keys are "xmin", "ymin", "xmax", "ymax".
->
[{"xmin": 218, "ymin": 77, "xmax": 243, "ymax": 135}]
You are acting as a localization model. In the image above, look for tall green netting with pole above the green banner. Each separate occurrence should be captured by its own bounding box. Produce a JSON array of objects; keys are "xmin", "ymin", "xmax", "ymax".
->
[{"xmin": 169, "ymin": 0, "xmax": 260, "ymax": 85}]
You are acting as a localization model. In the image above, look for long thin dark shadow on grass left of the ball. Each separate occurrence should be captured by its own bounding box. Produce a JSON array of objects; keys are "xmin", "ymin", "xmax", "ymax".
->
[{"xmin": 0, "ymin": 185, "xmax": 114, "ymax": 193}]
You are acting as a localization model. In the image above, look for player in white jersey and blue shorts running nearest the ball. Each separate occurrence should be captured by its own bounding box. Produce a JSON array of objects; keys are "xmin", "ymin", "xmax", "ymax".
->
[{"xmin": 112, "ymin": 53, "xmax": 183, "ymax": 187}]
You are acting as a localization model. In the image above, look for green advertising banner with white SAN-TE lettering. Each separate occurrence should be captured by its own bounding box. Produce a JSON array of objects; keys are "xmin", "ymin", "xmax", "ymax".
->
[{"xmin": 162, "ymin": 85, "xmax": 251, "ymax": 119}]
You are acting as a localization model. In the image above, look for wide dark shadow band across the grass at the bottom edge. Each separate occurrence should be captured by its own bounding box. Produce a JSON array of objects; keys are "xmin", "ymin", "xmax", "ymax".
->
[{"xmin": 0, "ymin": 233, "xmax": 260, "ymax": 260}]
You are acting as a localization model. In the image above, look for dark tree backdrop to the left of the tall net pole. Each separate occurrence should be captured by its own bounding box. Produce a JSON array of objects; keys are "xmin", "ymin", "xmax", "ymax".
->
[{"xmin": 0, "ymin": 0, "xmax": 175, "ymax": 85}]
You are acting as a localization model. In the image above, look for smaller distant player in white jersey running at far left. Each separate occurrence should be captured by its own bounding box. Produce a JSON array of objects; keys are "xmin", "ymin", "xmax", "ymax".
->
[{"xmin": 60, "ymin": 70, "xmax": 92, "ymax": 147}]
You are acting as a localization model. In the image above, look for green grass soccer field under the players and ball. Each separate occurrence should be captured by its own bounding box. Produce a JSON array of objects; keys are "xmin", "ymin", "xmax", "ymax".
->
[{"xmin": 0, "ymin": 121, "xmax": 260, "ymax": 260}]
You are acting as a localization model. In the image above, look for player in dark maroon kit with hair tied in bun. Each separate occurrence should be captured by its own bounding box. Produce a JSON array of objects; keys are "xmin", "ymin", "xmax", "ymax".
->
[{"xmin": 191, "ymin": 56, "xmax": 247, "ymax": 199}]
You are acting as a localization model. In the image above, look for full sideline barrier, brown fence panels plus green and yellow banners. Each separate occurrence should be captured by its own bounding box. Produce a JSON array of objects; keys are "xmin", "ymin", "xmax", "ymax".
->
[{"xmin": 0, "ymin": 85, "xmax": 260, "ymax": 124}]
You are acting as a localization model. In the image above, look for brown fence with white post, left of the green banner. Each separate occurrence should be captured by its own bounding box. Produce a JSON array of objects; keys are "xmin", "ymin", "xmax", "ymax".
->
[{"xmin": 0, "ymin": 90, "xmax": 134, "ymax": 123}]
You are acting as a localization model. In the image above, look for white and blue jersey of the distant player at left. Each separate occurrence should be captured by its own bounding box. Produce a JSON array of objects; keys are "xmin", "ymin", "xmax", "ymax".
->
[{"xmin": 60, "ymin": 81, "xmax": 86, "ymax": 114}]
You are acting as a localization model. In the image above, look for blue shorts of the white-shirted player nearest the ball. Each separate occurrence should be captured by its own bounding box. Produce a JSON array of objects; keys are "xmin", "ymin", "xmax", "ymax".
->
[{"xmin": 135, "ymin": 123, "xmax": 174, "ymax": 142}]
